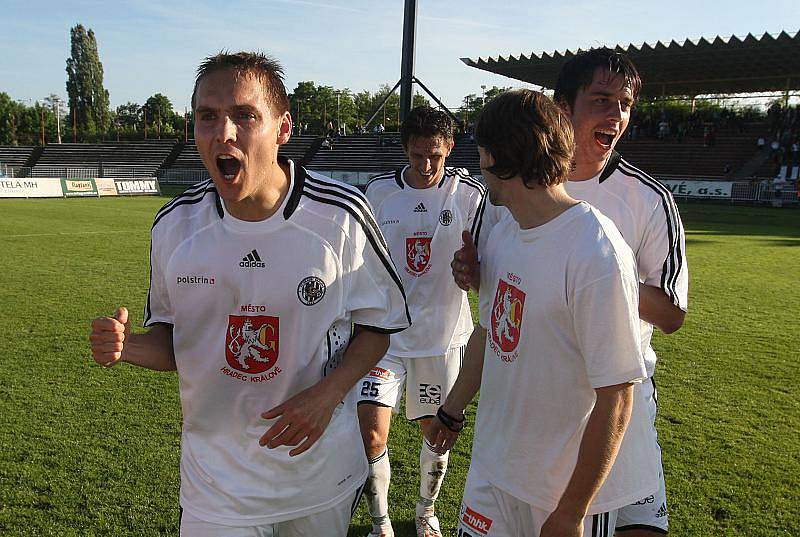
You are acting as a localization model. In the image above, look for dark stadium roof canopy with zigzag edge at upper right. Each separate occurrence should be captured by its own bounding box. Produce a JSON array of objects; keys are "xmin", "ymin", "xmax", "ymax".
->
[{"xmin": 461, "ymin": 32, "xmax": 800, "ymax": 97}]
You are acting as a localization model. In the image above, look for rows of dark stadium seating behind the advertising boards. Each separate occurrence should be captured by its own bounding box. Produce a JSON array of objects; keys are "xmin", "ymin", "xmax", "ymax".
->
[{"xmin": 0, "ymin": 124, "xmax": 773, "ymax": 178}]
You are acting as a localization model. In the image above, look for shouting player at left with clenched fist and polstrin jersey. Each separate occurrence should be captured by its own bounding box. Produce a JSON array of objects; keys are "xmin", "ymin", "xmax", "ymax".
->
[{"xmin": 90, "ymin": 52, "xmax": 410, "ymax": 537}]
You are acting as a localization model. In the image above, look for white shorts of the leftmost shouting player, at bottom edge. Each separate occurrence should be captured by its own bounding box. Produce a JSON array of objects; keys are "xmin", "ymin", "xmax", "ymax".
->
[{"xmin": 180, "ymin": 486, "xmax": 364, "ymax": 537}]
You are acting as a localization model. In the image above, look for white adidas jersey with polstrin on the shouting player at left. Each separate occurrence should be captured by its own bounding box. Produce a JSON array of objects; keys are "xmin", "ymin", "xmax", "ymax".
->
[{"xmin": 145, "ymin": 161, "xmax": 410, "ymax": 525}]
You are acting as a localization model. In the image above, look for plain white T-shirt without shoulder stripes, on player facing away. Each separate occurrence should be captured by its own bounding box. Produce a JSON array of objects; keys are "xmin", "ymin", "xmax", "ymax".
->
[{"xmin": 472, "ymin": 203, "xmax": 658, "ymax": 514}]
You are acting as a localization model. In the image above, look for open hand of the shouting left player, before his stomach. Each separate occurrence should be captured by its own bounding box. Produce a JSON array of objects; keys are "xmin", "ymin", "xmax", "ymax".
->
[{"xmin": 258, "ymin": 384, "xmax": 340, "ymax": 457}]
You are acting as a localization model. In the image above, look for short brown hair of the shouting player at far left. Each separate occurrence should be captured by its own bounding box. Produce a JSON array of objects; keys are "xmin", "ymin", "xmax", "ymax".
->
[{"xmin": 192, "ymin": 50, "xmax": 289, "ymax": 115}]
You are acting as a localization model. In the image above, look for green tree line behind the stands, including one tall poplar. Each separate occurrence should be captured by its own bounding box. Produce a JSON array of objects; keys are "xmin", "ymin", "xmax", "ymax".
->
[{"xmin": 0, "ymin": 24, "xmax": 507, "ymax": 145}]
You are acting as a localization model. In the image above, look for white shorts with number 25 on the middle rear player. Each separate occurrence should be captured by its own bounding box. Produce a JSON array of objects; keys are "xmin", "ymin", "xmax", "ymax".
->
[{"xmin": 356, "ymin": 346, "xmax": 464, "ymax": 420}]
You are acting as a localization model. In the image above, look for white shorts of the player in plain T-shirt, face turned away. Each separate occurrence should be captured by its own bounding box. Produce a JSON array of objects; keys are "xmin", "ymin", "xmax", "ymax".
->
[{"xmin": 457, "ymin": 467, "xmax": 616, "ymax": 537}]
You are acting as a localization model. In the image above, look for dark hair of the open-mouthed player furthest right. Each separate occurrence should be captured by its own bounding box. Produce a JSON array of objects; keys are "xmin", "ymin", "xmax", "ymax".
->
[{"xmin": 553, "ymin": 47, "xmax": 642, "ymax": 107}]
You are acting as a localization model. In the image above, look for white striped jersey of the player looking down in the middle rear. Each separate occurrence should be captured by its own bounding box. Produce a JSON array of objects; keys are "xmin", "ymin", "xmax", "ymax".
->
[{"xmin": 366, "ymin": 166, "xmax": 485, "ymax": 358}]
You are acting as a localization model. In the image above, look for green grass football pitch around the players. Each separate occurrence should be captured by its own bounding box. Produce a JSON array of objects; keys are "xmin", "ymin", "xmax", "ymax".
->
[{"xmin": 0, "ymin": 197, "xmax": 800, "ymax": 537}]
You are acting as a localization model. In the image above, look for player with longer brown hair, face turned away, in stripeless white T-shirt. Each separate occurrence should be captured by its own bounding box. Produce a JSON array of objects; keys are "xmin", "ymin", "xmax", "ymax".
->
[{"xmin": 432, "ymin": 90, "xmax": 657, "ymax": 537}]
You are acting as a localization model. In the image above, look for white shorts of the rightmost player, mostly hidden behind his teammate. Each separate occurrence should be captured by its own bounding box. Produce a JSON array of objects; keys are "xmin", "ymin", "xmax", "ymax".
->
[{"xmin": 616, "ymin": 378, "xmax": 669, "ymax": 535}]
